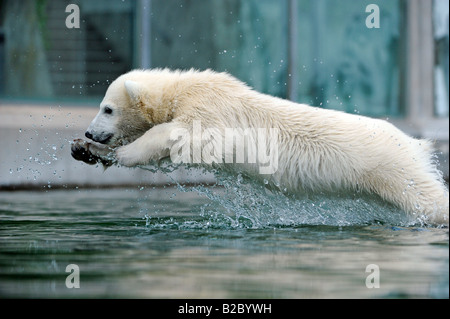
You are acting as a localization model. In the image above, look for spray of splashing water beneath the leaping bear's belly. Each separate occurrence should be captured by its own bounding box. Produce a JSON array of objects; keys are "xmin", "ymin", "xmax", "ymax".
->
[{"xmin": 136, "ymin": 162, "xmax": 414, "ymax": 229}]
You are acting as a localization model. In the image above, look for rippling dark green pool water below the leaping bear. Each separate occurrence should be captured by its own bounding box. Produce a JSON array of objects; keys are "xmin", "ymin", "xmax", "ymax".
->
[{"xmin": 0, "ymin": 187, "xmax": 449, "ymax": 298}]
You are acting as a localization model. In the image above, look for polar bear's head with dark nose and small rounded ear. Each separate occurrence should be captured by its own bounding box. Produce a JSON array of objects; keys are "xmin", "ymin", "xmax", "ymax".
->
[{"xmin": 85, "ymin": 71, "xmax": 173, "ymax": 147}]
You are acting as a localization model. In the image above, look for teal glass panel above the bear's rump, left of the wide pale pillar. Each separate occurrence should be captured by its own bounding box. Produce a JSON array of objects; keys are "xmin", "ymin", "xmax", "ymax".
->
[{"xmin": 296, "ymin": 0, "xmax": 402, "ymax": 116}]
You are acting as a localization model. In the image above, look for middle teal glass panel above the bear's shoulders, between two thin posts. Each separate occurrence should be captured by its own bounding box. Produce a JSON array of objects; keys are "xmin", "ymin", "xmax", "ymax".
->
[{"xmin": 151, "ymin": 0, "xmax": 288, "ymax": 97}]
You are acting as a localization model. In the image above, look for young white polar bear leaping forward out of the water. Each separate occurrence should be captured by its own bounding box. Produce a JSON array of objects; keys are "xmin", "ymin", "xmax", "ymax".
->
[{"xmin": 72, "ymin": 69, "xmax": 449, "ymax": 225}]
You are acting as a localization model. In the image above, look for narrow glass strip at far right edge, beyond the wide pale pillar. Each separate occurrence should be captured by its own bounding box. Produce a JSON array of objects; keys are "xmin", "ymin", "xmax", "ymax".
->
[{"xmin": 433, "ymin": 0, "xmax": 449, "ymax": 117}]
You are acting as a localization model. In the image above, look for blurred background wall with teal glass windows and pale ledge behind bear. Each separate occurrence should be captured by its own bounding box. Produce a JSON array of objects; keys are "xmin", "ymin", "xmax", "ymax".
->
[{"xmin": 0, "ymin": 0, "xmax": 449, "ymax": 189}]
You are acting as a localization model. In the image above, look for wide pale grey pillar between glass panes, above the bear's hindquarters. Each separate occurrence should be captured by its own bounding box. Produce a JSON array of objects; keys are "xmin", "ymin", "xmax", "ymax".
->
[{"xmin": 392, "ymin": 0, "xmax": 449, "ymax": 142}]
